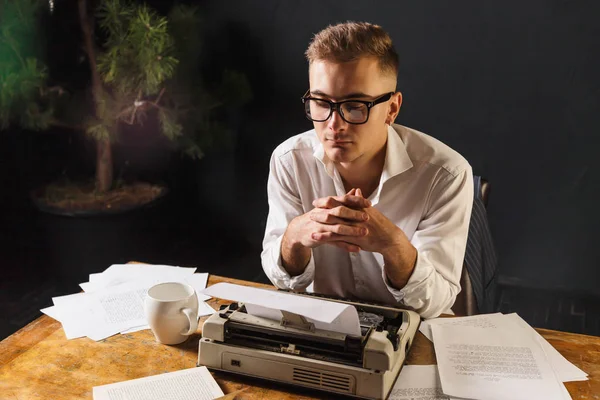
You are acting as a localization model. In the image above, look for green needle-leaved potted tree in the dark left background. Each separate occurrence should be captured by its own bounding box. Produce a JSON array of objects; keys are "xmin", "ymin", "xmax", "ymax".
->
[{"xmin": 0, "ymin": 0, "xmax": 250, "ymax": 279}]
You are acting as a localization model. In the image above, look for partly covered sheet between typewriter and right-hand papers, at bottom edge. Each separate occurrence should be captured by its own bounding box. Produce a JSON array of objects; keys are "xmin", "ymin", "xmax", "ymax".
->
[{"xmin": 388, "ymin": 365, "xmax": 453, "ymax": 400}]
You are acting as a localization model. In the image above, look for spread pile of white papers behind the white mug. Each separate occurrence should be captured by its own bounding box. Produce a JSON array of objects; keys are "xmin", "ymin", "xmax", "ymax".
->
[{"xmin": 41, "ymin": 264, "xmax": 215, "ymax": 340}]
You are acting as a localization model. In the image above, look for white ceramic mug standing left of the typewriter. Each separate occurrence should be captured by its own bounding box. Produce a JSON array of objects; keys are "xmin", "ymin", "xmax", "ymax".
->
[{"xmin": 144, "ymin": 282, "xmax": 198, "ymax": 344}]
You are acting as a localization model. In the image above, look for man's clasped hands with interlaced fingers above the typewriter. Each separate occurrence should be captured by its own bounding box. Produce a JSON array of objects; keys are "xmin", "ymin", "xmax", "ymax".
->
[{"xmin": 290, "ymin": 189, "xmax": 403, "ymax": 255}]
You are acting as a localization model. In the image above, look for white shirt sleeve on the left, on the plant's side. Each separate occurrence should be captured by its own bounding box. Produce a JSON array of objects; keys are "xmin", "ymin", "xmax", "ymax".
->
[{"xmin": 261, "ymin": 152, "xmax": 315, "ymax": 290}]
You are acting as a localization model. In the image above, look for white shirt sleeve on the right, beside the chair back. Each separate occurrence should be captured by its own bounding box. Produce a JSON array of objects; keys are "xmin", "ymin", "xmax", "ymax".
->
[{"xmin": 383, "ymin": 166, "xmax": 473, "ymax": 318}]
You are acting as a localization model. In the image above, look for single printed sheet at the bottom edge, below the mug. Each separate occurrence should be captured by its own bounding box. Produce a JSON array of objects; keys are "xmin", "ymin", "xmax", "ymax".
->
[{"xmin": 92, "ymin": 367, "xmax": 224, "ymax": 400}]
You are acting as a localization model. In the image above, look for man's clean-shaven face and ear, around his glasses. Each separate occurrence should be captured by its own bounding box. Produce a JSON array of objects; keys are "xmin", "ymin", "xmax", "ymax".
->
[{"xmin": 309, "ymin": 57, "xmax": 401, "ymax": 163}]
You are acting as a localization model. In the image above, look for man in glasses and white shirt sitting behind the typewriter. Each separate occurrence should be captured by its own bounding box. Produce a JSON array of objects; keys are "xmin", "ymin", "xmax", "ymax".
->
[{"xmin": 262, "ymin": 22, "xmax": 473, "ymax": 318}]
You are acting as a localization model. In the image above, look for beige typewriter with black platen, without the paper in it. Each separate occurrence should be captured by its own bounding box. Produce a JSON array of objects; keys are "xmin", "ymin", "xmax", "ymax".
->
[{"xmin": 198, "ymin": 294, "xmax": 420, "ymax": 399}]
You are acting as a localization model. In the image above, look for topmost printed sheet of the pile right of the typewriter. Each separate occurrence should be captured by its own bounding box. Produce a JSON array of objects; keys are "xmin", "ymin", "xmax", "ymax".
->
[{"xmin": 431, "ymin": 320, "xmax": 564, "ymax": 400}]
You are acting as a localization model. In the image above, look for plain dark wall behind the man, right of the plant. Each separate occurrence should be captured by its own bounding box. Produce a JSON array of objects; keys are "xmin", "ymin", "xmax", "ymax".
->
[{"xmin": 196, "ymin": 0, "xmax": 600, "ymax": 293}]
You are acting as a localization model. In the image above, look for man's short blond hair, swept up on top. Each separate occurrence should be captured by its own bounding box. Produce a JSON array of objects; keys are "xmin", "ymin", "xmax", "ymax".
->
[{"xmin": 306, "ymin": 21, "xmax": 399, "ymax": 77}]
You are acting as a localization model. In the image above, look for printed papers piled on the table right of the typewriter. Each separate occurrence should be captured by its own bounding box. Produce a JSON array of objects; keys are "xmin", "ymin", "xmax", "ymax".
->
[{"xmin": 390, "ymin": 313, "xmax": 587, "ymax": 400}]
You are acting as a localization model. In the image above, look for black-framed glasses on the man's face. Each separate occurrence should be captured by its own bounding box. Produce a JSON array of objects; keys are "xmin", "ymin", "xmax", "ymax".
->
[{"xmin": 302, "ymin": 89, "xmax": 394, "ymax": 125}]
